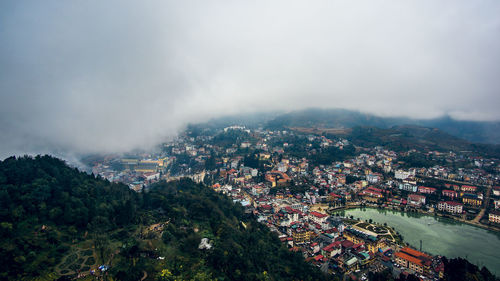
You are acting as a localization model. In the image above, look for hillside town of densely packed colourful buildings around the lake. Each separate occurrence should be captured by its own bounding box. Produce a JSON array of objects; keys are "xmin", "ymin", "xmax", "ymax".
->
[{"xmin": 91, "ymin": 126, "xmax": 500, "ymax": 280}]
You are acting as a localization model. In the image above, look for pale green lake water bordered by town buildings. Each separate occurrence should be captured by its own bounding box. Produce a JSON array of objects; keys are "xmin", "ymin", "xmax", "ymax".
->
[{"xmin": 339, "ymin": 208, "xmax": 500, "ymax": 276}]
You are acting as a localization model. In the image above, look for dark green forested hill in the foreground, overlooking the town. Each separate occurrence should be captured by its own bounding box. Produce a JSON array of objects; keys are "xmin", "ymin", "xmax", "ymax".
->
[{"xmin": 0, "ymin": 156, "xmax": 324, "ymax": 280}]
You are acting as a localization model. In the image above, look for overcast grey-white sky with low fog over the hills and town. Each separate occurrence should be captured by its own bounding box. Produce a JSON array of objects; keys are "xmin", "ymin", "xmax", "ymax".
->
[{"xmin": 0, "ymin": 0, "xmax": 500, "ymax": 159}]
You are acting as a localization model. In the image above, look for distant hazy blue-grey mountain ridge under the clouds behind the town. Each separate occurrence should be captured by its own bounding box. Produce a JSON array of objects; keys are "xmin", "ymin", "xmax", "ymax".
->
[{"xmin": 267, "ymin": 109, "xmax": 500, "ymax": 144}]
